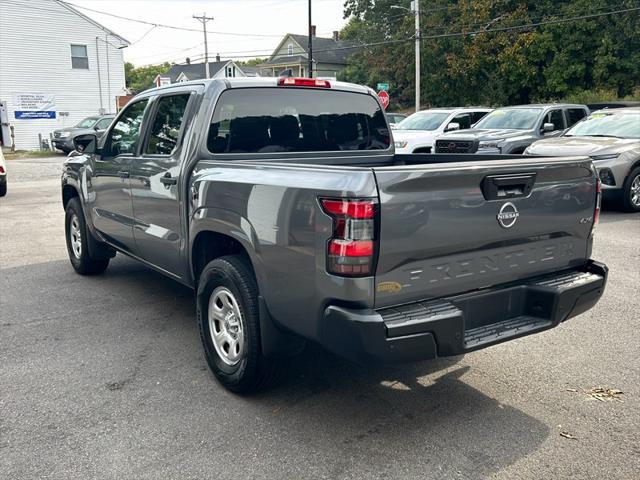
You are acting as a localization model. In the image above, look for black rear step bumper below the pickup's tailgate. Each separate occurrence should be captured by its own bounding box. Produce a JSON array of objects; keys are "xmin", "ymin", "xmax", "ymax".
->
[{"xmin": 321, "ymin": 261, "xmax": 608, "ymax": 364}]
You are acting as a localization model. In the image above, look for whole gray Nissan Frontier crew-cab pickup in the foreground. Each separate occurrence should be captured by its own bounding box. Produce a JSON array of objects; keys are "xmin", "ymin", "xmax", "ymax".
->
[{"xmin": 62, "ymin": 78, "xmax": 607, "ymax": 392}]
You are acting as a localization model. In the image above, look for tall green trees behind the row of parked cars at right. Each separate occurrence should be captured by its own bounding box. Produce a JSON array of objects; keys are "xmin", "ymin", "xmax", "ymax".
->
[{"xmin": 340, "ymin": 0, "xmax": 640, "ymax": 108}]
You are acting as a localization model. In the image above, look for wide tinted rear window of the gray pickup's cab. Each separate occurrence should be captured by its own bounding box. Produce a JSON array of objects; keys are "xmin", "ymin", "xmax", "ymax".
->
[{"xmin": 207, "ymin": 87, "xmax": 390, "ymax": 153}]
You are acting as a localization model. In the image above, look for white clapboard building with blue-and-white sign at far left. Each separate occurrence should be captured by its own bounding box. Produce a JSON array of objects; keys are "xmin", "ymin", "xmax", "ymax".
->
[{"xmin": 0, "ymin": 0, "xmax": 129, "ymax": 150}]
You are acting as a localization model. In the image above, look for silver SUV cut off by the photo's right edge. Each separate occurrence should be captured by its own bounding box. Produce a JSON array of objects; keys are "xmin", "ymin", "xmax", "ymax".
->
[{"xmin": 525, "ymin": 107, "xmax": 640, "ymax": 212}]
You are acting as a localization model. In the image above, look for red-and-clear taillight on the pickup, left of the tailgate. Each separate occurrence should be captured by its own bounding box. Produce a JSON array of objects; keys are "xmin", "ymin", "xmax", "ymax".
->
[{"xmin": 320, "ymin": 198, "xmax": 376, "ymax": 277}]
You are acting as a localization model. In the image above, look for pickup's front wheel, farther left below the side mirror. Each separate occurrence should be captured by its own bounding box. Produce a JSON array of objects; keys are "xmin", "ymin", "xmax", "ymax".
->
[{"xmin": 64, "ymin": 197, "xmax": 110, "ymax": 275}]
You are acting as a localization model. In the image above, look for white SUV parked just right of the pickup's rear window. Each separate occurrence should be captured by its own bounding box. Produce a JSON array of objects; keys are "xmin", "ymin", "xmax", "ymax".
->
[{"xmin": 393, "ymin": 107, "xmax": 491, "ymax": 153}]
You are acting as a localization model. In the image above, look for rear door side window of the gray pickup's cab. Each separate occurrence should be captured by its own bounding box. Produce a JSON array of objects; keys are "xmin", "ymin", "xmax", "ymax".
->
[{"xmin": 145, "ymin": 93, "xmax": 191, "ymax": 155}]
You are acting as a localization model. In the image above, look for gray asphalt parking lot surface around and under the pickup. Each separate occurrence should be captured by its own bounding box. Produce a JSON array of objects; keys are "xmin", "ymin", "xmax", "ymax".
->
[{"xmin": 0, "ymin": 157, "xmax": 640, "ymax": 480}]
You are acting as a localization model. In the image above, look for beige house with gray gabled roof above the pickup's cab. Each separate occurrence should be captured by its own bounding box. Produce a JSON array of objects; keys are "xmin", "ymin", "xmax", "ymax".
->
[{"xmin": 260, "ymin": 31, "xmax": 358, "ymax": 78}]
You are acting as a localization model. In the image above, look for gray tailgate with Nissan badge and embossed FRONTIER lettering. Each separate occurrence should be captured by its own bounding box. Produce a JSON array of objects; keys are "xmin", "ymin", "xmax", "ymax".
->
[{"xmin": 373, "ymin": 157, "xmax": 597, "ymax": 308}]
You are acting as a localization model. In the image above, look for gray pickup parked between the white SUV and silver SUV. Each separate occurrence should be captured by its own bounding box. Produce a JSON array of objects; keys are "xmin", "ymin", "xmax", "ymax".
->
[{"xmin": 436, "ymin": 104, "xmax": 589, "ymax": 154}]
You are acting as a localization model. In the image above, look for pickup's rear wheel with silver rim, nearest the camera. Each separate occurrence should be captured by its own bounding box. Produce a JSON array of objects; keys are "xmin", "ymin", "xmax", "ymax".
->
[{"xmin": 197, "ymin": 255, "xmax": 275, "ymax": 393}]
